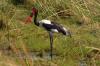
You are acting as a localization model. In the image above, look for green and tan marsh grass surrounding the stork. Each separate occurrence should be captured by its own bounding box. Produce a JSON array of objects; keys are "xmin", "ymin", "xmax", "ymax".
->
[{"xmin": 0, "ymin": 0, "xmax": 100, "ymax": 66}]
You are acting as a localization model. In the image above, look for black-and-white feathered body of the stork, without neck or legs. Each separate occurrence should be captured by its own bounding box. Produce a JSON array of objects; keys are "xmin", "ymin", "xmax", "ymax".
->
[{"xmin": 39, "ymin": 19, "xmax": 68, "ymax": 35}]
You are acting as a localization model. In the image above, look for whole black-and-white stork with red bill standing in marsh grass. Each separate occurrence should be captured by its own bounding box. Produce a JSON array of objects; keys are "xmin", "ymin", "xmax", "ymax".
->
[{"xmin": 26, "ymin": 7, "xmax": 71, "ymax": 59}]
